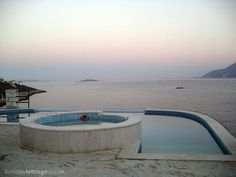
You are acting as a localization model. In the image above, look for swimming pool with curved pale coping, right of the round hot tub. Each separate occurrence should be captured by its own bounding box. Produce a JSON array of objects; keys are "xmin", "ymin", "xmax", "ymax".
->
[{"xmin": 117, "ymin": 109, "xmax": 236, "ymax": 162}]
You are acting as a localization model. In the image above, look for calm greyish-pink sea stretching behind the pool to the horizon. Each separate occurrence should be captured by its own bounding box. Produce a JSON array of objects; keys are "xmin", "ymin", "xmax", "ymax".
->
[{"xmin": 25, "ymin": 79, "xmax": 236, "ymax": 137}]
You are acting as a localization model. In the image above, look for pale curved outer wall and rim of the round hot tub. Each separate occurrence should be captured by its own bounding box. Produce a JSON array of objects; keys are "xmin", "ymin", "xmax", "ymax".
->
[{"xmin": 20, "ymin": 112, "xmax": 141, "ymax": 153}]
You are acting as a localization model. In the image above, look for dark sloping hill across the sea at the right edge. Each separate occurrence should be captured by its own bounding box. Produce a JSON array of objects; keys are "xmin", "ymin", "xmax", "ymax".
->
[{"xmin": 202, "ymin": 63, "xmax": 236, "ymax": 78}]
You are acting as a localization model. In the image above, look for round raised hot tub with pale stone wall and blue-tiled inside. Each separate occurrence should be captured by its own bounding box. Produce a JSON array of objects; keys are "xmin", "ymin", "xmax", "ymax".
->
[{"xmin": 20, "ymin": 112, "xmax": 141, "ymax": 153}]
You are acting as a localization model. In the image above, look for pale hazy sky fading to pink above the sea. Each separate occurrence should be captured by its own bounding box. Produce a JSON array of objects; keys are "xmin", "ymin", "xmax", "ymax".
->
[{"xmin": 0, "ymin": 0, "xmax": 236, "ymax": 80}]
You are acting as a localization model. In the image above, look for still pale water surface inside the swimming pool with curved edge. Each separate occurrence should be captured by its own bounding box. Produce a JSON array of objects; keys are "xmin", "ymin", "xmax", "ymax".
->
[{"xmin": 141, "ymin": 115, "xmax": 223, "ymax": 154}]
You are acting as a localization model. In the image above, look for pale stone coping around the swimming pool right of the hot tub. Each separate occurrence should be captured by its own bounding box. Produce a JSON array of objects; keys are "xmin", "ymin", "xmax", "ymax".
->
[{"xmin": 117, "ymin": 109, "xmax": 236, "ymax": 162}]
